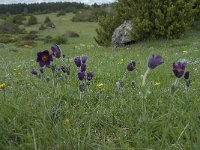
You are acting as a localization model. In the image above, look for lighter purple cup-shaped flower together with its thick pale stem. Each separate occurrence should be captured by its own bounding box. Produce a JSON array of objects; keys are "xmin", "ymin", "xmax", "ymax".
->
[{"xmin": 142, "ymin": 54, "xmax": 164, "ymax": 86}]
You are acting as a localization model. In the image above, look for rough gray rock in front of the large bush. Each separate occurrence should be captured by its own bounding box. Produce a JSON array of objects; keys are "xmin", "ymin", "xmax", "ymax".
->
[{"xmin": 111, "ymin": 21, "xmax": 135, "ymax": 48}]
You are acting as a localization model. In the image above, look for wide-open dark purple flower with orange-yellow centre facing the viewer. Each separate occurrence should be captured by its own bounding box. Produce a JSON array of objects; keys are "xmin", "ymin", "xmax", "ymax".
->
[{"xmin": 37, "ymin": 50, "xmax": 53, "ymax": 67}]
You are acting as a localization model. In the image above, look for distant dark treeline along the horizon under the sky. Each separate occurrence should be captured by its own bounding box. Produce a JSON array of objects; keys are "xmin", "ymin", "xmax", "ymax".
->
[{"xmin": 0, "ymin": 2, "xmax": 89, "ymax": 14}]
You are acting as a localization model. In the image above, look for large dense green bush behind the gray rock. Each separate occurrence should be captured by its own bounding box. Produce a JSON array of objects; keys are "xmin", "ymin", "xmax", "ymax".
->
[{"xmin": 96, "ymin": 0, "xmax": 197, "ymax": 45}]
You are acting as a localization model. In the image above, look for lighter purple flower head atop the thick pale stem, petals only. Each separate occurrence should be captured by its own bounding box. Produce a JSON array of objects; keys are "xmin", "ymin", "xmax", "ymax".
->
[{"xmin": 148, "ymin": 55, "xmax": 164, "ymax": 69}]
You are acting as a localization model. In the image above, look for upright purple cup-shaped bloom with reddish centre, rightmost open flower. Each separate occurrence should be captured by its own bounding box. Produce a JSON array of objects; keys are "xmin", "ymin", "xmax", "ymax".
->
[{"xmin": 173, "ymin": 62, "xmax": 186, "ymax": 78}]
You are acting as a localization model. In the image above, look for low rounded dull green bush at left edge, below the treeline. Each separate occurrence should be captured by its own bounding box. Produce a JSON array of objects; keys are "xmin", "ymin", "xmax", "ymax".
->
[{"xmin": 0, "ymin": 21, "xmax": 25, "ymax": 34}]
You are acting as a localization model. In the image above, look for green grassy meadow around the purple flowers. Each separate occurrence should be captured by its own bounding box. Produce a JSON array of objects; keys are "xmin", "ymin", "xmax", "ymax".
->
[{"xmin": 0, "ymin": 14, "xmax": 200, "ymax": 150}]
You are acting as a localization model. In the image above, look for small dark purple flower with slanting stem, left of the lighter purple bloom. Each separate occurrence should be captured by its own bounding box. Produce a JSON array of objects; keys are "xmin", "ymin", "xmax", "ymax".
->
[{"xmin": 116, "ymin": 60, "xmax": 136, "ymax": 89}]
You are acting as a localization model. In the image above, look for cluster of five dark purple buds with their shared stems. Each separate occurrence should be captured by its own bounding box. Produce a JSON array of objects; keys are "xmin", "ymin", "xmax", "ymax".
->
[{"xmin": 74, "ymin": 55, "xmax": 94, "ymax": 99}]
